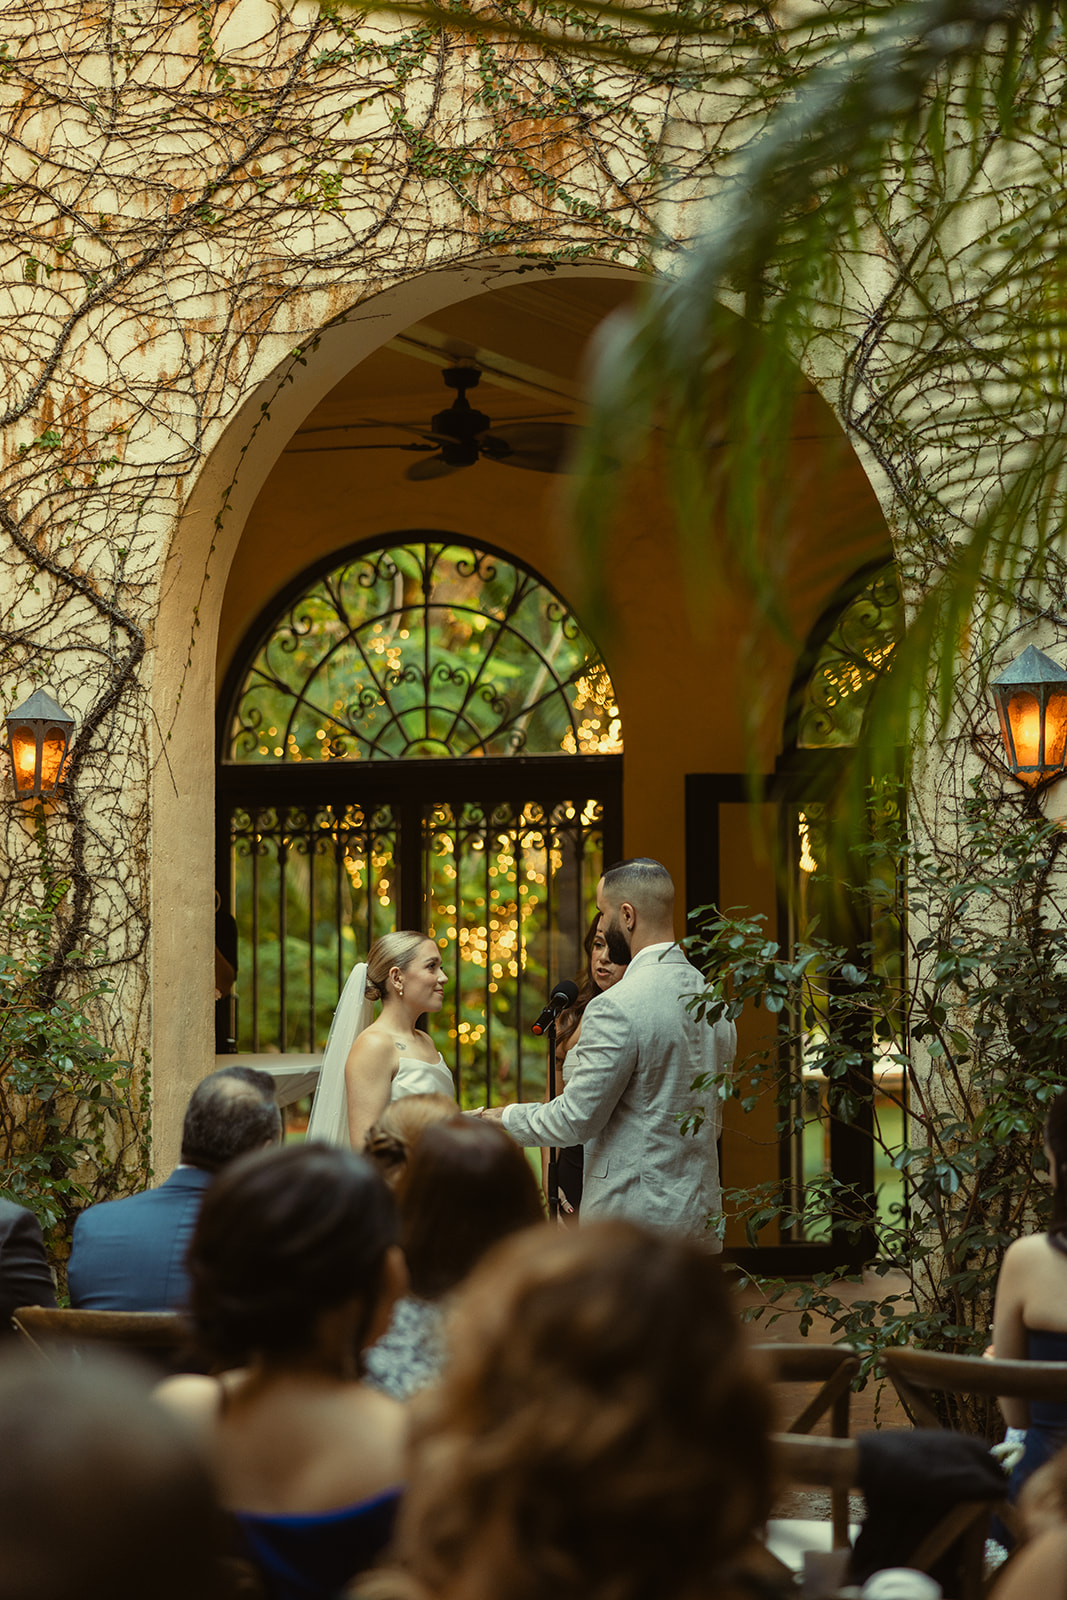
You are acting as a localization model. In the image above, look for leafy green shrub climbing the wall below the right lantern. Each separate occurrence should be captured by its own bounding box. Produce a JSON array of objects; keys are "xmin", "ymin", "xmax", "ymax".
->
[{"xmin": 691, "ymin": 784, "xmax": 1067, "ymax": 1430}]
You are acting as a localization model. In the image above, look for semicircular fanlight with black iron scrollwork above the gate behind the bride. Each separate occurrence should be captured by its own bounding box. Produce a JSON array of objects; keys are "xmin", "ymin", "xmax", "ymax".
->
[{"xmin": 227, "ymin": 542, "xmax": 622, "ymax": 762}]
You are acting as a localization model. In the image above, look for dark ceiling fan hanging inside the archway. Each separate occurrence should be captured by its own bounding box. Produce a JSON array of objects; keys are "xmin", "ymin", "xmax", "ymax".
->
[{"xmin": 383, "ymin": 366, "xmax": 584, "ymax": 483}]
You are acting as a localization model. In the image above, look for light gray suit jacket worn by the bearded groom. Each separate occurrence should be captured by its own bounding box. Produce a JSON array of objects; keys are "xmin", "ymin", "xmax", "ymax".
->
[{"xmin": 504, "ymin": 944, "xmax": 737, "ymax": 1250}]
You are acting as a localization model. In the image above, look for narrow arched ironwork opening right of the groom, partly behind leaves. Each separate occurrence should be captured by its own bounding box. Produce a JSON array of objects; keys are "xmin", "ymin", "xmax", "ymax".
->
[{"xmin": 781, "ymin": 562, "xmax": 907, "ymax": 1262}]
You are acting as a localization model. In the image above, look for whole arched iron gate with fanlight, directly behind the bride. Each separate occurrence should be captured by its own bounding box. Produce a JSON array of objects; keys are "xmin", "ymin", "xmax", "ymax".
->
[{"xmin": 216, "ymin": 530, "xmax": 622, "ymax": 1101}]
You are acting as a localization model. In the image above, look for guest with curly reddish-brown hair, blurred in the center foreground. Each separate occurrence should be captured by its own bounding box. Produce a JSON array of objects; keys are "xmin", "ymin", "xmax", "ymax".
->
[{"xmin": 367, "ymin": 1221, "xmax": 771, "ymax": 1600}]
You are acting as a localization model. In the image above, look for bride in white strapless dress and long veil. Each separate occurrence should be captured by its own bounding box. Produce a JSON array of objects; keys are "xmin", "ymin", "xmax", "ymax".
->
[{"xmin": 307, "ymin": 933, "xmax": 456, "ymax": 1150}]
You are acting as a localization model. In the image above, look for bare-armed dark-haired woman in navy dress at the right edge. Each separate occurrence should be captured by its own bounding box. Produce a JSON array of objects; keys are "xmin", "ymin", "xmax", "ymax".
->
[{"xmin": 993, "ymin": 1090, "xmax": 1067, "ymax": 1499}]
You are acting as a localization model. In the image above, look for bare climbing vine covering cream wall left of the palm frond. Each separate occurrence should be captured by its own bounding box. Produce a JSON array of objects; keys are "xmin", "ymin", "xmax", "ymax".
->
[{"xmin": 0, "ymin": 0, "xmax": 766, "ymax": 1194}]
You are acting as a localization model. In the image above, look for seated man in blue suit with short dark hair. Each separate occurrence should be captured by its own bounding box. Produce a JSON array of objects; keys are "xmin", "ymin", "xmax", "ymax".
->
[{"xmin": 67, "ymin": 1067, "xmax": 282, "ymax": 1310}]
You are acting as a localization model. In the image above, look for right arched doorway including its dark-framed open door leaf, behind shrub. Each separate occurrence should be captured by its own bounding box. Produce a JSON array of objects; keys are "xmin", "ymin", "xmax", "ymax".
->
[{"xmin": 686, "ymin": 554, "xmax": 905, "ymax": 1275}]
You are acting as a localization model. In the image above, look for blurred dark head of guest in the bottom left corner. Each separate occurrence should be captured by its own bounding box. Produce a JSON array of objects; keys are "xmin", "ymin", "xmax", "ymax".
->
[{"xmin": 0, "ymin": 1350, "xmax": 229, "ymax": 1600}]
